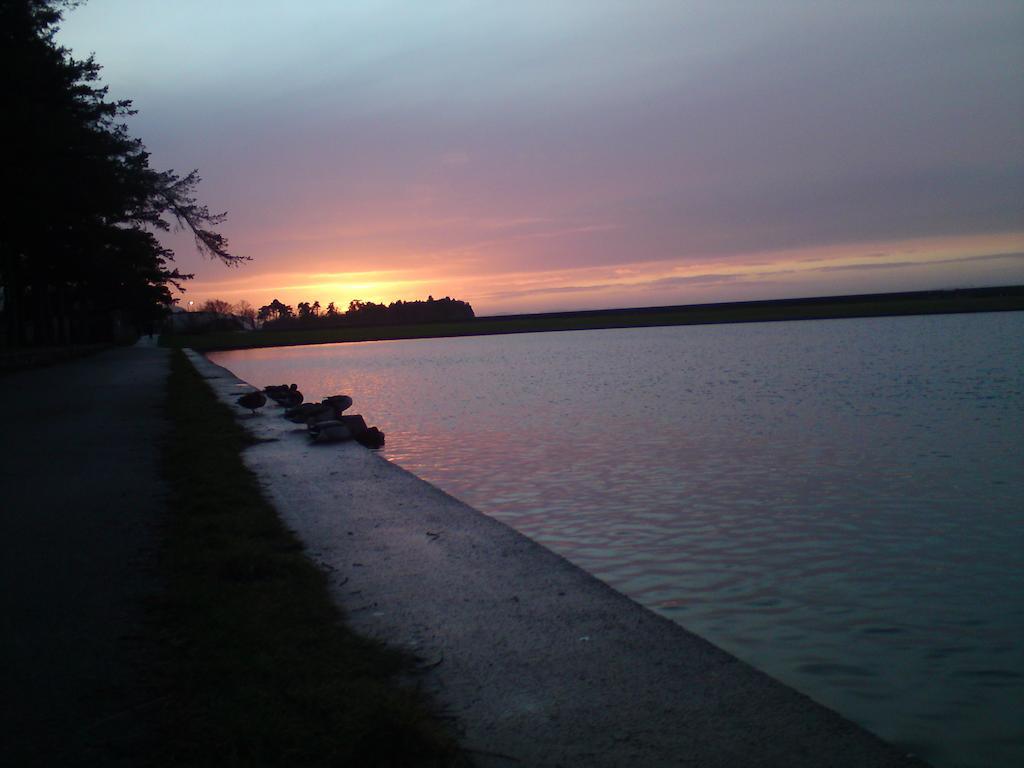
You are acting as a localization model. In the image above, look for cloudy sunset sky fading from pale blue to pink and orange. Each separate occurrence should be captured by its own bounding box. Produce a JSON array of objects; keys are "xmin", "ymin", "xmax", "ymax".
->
[{"xmin": 57, "ymin": 0, "xmax": 1024, "ymax": 314}]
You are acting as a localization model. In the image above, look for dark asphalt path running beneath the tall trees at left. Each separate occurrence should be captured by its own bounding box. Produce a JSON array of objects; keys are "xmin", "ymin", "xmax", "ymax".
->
[{"xmin": 0, "ymin": 347, "xmax": 169, "ymax": 766}]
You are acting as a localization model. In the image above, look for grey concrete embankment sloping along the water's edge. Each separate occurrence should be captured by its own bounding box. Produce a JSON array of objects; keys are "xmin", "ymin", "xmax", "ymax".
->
[{"xmin": 189, "ymin": 353, "xmax": 923, "ymax": 768}]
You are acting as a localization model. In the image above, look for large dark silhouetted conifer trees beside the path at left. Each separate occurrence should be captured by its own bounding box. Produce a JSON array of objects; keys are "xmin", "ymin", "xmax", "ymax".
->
[{"xmin": 0, "ymin": 0, "xmax": 243, "ymax": 344}]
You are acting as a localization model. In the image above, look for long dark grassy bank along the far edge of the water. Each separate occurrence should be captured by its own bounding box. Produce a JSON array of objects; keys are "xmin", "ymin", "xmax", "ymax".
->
[{"xmin": 163, "ymin": 286, "xmax": 1024, "ymax": 351}]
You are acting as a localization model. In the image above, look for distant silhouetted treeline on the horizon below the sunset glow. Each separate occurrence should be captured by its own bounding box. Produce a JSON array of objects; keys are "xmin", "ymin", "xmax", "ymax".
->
[{"xmin": 256, "ymin": 296, "xmax": 474, "ymax": 331}]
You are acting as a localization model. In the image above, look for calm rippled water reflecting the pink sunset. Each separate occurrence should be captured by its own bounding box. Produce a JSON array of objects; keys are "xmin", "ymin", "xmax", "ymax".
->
[{"xmin": 213, "ymin": 312, "xmax": 1024, "ymax": 766}]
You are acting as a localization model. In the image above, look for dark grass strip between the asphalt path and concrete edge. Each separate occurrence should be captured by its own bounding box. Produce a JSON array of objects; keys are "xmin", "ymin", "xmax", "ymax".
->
[{"xmin": 155, "ymin": 351, "xmax": 461, "ymax": 766}]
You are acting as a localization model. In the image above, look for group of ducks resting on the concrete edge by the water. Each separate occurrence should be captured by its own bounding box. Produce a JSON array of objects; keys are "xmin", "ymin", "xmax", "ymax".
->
[{"xmin": 236, "ymin": 384, "xmax": 384, "ymax": 449}]
